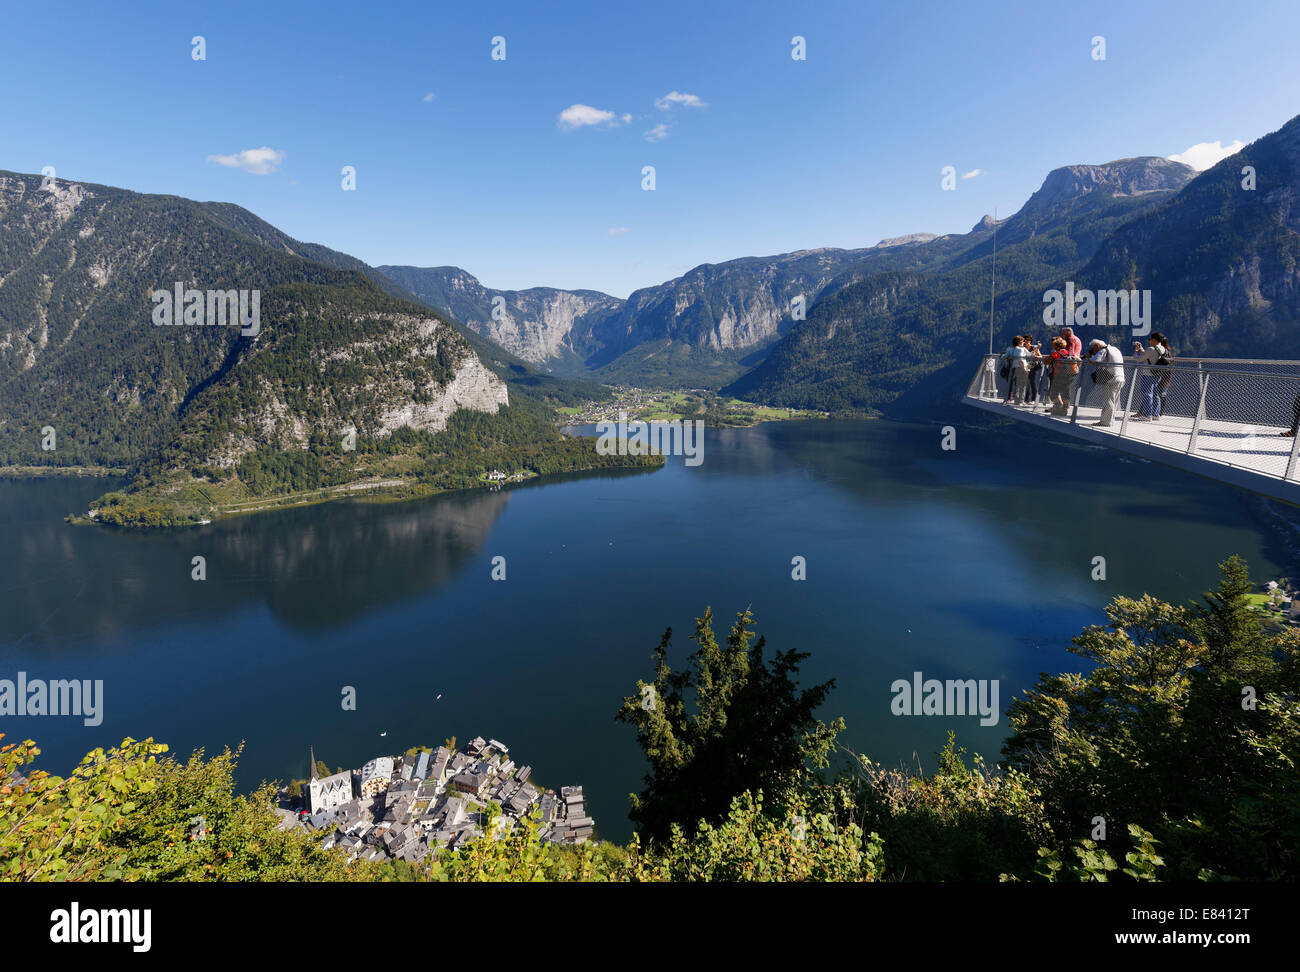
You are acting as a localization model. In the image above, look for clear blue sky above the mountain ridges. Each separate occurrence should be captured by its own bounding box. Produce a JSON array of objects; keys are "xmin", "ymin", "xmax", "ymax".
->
[{"xmin": 0, "ymin": 0, "xmax": 1300, "ymax": 296}]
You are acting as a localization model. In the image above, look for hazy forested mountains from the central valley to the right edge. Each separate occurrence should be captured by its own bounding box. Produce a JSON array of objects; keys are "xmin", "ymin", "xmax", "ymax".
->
[{"xmin": 380, "ymin": 120, "xmax": 1300, "ymax": 416}]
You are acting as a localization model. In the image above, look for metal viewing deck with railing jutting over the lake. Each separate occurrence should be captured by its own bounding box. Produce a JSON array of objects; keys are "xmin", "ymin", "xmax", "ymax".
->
[{"xmin": 963, "ymin": 355, "xmax": 1300, "ymax": 504}]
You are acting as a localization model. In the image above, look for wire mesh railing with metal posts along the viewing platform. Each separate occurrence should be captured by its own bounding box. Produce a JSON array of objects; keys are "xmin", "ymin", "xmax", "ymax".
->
[{"xmin": 966, "ymin": 355, "xmax": 1300, "ymax": 481}]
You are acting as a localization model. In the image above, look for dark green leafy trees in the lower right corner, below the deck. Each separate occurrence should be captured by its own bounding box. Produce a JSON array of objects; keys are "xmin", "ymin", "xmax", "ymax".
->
[{"xmin": 1003, "ymin": 557, "xmax": 1300, "ymax": 880}]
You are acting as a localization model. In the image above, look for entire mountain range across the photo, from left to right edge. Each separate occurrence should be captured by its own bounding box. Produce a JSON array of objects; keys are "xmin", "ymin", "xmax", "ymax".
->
[{"xmin": 0, "ymin": 109, "xmax": 1300, "ymax": 519}]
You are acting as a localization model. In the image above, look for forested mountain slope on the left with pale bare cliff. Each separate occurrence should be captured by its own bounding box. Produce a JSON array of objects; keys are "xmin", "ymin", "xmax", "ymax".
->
[{"xmin": 0, "ymin": 173, "xmax": 650, "ymax": 522}]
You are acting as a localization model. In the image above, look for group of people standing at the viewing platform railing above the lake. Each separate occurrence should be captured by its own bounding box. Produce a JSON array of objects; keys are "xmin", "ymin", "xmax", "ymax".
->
[{"xmin": 1002, "ymin": 327, "xmax": 1175, "ymax": 434}]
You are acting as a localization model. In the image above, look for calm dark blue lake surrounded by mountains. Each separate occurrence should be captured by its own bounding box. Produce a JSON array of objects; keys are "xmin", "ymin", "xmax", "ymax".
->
[{"xmin": 0, "ymin": 418, "xmax": 1294, "ymax": 839}]
